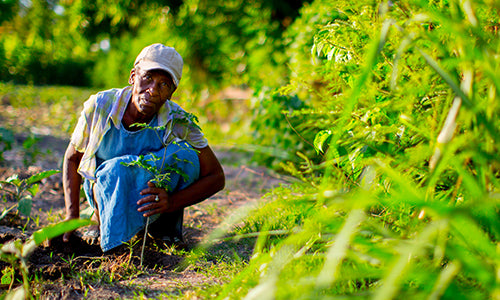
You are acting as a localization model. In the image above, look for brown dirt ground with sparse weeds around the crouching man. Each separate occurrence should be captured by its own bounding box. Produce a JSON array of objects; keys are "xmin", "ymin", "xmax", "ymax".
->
[{"xmin": 0, "ymin": 137, "xmax": 285, "ymax": 299}]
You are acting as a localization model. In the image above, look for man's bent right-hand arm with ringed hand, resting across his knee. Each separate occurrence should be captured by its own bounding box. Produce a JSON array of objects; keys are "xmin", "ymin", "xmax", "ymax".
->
[{"xmin": 137, "ymin": 146, "xmax": 225, "ymax": 217}]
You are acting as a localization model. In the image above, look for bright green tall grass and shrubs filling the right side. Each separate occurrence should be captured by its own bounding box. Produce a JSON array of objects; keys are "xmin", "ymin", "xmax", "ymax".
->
[{"xmin": 213, "ymin": 0, "xmax": 500, "ymax": 299}]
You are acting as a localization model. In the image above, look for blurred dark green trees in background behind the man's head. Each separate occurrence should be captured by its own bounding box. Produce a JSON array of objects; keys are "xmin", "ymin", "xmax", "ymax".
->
[{"xmin": 0, "ymin": 0, "xmax": 308, "ymax": 88}]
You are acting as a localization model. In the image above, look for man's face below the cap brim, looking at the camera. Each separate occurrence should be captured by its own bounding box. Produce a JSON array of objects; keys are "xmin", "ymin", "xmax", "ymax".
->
[{"xmin": 129, "ymin": 68, "xmax": 174, "ymax": 117}]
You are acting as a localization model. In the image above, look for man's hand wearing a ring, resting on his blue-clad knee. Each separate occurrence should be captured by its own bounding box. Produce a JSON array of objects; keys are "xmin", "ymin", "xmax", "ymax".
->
[{"xmin": 137, "ymin": 182, "xmax": 170, "ymax": 217}]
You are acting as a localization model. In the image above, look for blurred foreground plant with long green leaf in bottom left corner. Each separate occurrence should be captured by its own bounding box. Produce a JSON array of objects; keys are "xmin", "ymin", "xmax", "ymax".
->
[{"xmin": 0, "ymin": 219, "xmax": 92, "ymax": 299}]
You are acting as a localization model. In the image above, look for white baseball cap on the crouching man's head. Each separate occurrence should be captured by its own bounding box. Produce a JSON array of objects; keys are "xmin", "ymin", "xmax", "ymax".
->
[{"xmin": 134, "ymin": 44, "xmax": 184, "ymax": 87}]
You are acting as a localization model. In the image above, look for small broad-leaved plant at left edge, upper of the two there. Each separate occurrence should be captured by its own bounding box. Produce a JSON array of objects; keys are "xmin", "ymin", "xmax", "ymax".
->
[{"xmin": 0, "ymin": 170, "xmax": 60, "ymax": 219}]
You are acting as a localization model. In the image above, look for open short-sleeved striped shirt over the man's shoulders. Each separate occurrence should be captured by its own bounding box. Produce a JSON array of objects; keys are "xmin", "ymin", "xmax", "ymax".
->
[{"xmin": 71, "ymin": 86, "xmax": 208, "ymax": 181}]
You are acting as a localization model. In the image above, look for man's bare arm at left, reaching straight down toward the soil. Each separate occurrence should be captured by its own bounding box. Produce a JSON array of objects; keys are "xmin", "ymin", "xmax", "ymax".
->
[{"xmin": 62, "ymin": 144, "xmax": 83, "ymax": 242}]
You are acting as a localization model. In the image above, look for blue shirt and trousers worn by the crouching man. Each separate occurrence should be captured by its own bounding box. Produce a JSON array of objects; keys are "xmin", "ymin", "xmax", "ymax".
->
[{"xmin": 84, "ymin": 116, "xmax": 200, "ymax": 251}]
